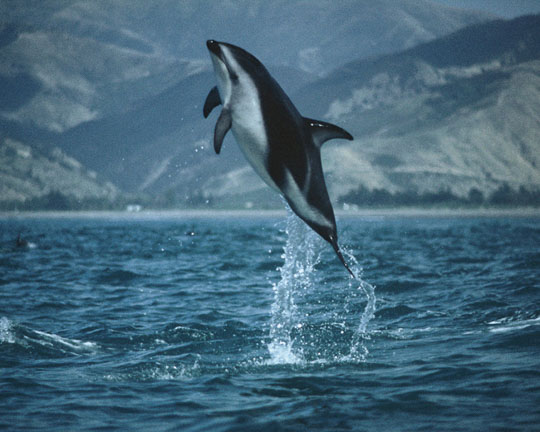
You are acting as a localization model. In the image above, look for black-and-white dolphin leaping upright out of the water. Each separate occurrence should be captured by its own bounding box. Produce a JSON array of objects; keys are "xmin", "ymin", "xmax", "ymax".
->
[{"xmin": 203, "ymin": 40, "xmax": 355, "ymax": 277}]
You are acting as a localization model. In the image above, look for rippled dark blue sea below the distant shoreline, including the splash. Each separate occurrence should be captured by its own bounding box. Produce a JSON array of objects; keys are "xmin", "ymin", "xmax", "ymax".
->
[{"xmin": 0, "ymin": 215, "xmax": 540, "ymax": 432}]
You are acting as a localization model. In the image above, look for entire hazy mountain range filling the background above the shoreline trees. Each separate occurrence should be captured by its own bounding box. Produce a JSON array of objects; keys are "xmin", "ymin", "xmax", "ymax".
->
[{"xmin": 0, "ymin": 0, "xmax": 540, "ymax": 206}]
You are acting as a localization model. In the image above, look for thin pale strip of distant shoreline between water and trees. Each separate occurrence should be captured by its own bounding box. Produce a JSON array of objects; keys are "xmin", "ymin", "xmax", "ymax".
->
[{"xmin": 0, "ymin": 207, "xmax": 540, "ymax": 220}]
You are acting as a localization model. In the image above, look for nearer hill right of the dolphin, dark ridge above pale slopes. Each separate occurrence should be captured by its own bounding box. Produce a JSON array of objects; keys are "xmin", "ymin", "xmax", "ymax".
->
[{"xmin": 296, "ymin": 16, "xmax": 540, "ymax": 202}]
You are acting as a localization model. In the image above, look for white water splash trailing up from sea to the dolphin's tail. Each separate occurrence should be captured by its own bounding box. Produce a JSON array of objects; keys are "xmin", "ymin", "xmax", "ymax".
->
[{"xmin": 268, "ymin": 207, "xmax": 376, "ymax": 364}]
